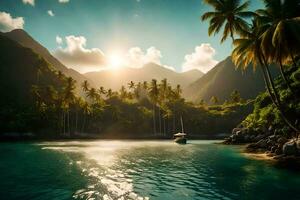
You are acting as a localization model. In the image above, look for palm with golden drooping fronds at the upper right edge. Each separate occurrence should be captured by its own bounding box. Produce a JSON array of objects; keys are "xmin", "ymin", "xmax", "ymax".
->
[{"xmin": 257, "ymin": 0, "xmax": 300, "ymax": 93}]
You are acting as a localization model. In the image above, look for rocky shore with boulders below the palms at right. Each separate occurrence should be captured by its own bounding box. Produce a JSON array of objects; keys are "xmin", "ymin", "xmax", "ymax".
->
[{"xmin": 223, "ymin": 127, "xmax": 300, "ymax": 170}]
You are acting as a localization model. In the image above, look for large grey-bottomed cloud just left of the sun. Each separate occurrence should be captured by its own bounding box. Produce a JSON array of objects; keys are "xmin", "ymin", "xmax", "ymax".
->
[{"xmin": 53, "ymin": 35, "xmax": 106, "ymax": 73}]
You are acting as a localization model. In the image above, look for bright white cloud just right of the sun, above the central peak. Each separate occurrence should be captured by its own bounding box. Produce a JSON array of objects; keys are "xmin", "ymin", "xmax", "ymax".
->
[{"xmin": 125, "ymin": 47, "xmax": 174, "ymax": 70}]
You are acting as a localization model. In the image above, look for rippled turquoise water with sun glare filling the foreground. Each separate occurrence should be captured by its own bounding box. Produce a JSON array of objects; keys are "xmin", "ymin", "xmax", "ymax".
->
[{"xmin": 0, "ymin": 140, "xmax": 300, "ymax": 200}]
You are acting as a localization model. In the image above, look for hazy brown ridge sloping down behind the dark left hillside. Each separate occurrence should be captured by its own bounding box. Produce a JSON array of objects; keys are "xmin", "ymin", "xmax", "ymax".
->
[{"xmin": 0, "ymin": 29, "xmax": 91, "ymax": 89}]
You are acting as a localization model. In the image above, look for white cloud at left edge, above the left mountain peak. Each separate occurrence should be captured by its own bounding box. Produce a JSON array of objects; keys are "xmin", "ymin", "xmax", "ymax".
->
[{"xmin": 0, "ymin": 12, "xmax": 25, "ymax": 32}]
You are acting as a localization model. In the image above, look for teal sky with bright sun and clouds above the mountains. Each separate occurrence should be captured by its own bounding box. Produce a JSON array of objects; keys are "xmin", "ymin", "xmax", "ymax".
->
[{"xmin": 0, "ymin": 0, "xmax": 261, "ymax": 73}]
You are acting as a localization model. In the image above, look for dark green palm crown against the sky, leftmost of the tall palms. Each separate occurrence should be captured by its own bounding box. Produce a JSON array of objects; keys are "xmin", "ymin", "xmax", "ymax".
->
[{"xmin": 201, "ymin": 0, "xmax": 253, "ymax": 43}]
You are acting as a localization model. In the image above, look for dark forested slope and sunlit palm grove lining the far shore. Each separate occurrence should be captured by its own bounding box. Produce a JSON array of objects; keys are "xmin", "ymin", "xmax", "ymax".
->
[{"xmin": 0, "ymin": 33, "xmax": 252, "ymax": 138}]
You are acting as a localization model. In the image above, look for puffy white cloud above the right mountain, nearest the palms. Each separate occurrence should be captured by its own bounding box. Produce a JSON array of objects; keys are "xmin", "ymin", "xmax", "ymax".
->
[{"xmin": 182, "ymin": 43, "xmax": 218, "ymax": 73}]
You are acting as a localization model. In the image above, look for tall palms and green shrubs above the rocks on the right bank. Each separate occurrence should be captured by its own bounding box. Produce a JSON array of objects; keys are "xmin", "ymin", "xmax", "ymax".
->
[{"xmin": 202, "ymin": 0, "xmax": 300, "ymax": 133}]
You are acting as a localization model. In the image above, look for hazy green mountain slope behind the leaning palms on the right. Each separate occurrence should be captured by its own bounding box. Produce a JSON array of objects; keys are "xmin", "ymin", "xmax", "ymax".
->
[{"xmin": 184, "ymin": 57, "xmax": 277, "ymax": 102}]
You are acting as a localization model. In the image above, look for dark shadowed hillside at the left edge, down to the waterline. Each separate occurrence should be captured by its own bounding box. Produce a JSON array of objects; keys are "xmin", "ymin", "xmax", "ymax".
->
[{"xmin": 0, "ymin": 35, "xmax": 65, "ymax": 132}]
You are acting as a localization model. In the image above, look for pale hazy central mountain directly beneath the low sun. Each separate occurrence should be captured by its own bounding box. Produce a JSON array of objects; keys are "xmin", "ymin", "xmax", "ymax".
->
[{"xmin": 84, "ymin": 63, "xmax": 203, "ymax": 90}]
